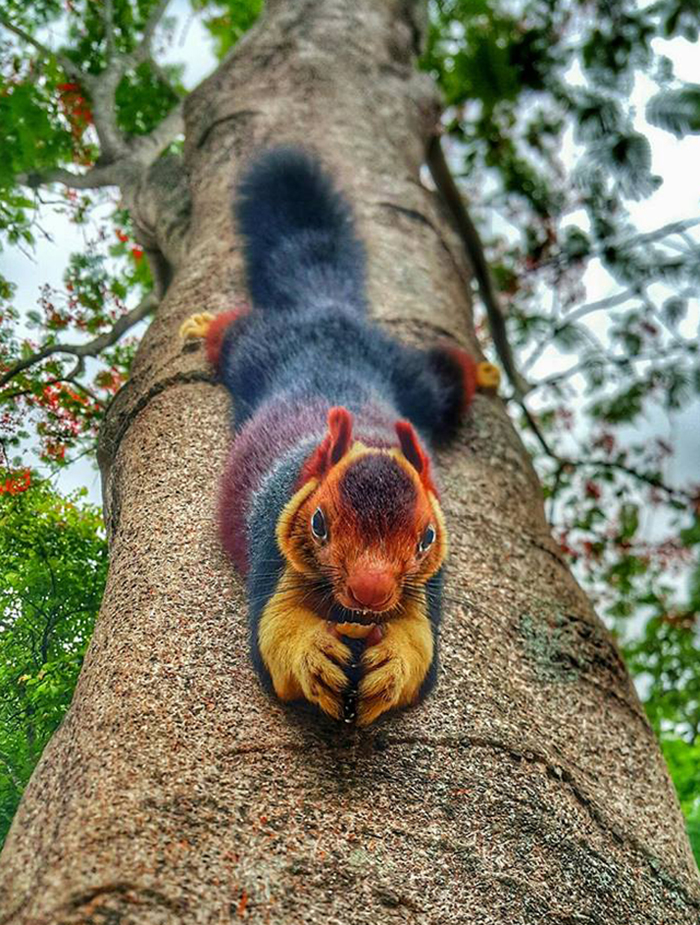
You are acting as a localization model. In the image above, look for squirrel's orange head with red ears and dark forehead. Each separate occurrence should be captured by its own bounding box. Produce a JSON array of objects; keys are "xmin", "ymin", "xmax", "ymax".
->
[{"xmin": 277, "ymin": 408, "xmax": 447, "ymax": 622}]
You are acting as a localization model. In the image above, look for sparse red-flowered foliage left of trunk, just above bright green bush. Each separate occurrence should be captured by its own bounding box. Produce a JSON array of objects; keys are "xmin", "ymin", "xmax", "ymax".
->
[{"xmin": 0, "ymin": 218, "xmax": 150, "ymax": 466}]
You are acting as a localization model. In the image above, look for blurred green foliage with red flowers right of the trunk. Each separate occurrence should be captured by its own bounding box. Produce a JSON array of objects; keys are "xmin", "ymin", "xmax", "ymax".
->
[{"xmin": 423, "ymin": 0, "xmax": 700, "ymax": 856}]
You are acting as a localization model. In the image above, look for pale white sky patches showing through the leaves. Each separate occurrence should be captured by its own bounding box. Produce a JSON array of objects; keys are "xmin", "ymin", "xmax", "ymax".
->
[{"xmin": 0, "ymin": 0, "xmax": 700, "ymax": 501}]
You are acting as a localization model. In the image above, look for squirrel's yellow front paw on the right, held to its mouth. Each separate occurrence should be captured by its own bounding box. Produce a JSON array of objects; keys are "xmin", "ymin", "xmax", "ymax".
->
[{"xmin": 357, "ymin": 620, "xmax": 433, "ymax": 726}]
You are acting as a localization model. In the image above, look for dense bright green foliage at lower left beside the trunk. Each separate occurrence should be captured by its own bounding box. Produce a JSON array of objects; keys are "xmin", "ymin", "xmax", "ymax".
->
[{"xmin": 0, "ymin": 470, "xmax": 107, "ymax": 841}]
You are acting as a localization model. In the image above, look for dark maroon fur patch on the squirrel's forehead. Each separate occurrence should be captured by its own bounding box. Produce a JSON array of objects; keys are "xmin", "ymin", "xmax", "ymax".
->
[{"xmin": 340, "ymin": 453, "xmax": 417, "ymax": 536}]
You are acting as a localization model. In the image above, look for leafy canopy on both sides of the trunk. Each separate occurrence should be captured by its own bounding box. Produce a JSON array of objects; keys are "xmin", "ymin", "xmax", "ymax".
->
[{"xmin": 0, "ymin": 0, "xmax": 700, "ymax": 852}]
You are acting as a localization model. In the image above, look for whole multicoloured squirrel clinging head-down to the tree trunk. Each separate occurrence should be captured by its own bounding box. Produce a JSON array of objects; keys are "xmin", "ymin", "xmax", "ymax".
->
[{"xmin": 180, "ymin": 147, "xmax": 498, "ymax": 726}]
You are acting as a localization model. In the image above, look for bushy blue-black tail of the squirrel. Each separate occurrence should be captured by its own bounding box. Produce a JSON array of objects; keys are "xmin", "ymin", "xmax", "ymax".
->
[{"xmin": 234, "ymin": 147, "xmax": 365, "ymax": 311}]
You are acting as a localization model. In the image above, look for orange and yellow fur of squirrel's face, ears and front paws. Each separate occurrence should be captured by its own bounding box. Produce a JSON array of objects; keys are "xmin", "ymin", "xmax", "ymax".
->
[{"xmin": 268, "ymin": 409, "xmax": 447, "ymax": 725}]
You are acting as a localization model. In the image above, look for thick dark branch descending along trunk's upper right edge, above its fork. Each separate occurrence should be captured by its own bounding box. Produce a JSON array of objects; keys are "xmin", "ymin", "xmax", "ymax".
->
[{"xmin": 427, "ymin": 135, "xmax": 531, "ymax": 399}]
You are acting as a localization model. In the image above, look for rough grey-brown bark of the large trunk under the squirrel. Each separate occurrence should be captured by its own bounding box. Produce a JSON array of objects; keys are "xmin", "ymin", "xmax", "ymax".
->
[{"xmin": 0, "ymin": 0, "xmax": 700, "ymax": 925}]
